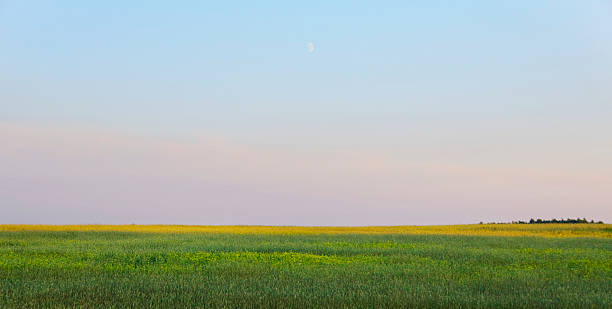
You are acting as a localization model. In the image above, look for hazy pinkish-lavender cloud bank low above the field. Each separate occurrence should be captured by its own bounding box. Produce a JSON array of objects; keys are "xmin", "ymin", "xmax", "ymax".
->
[{"xmin": 0, "ymin": 124, "xmax": 612, "ymax": 225}]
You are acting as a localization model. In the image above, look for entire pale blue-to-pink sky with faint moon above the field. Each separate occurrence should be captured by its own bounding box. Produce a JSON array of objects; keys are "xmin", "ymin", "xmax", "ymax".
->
[{"xmin": 0, "ymin": 0, "xmax": 612, "ymax": 225}]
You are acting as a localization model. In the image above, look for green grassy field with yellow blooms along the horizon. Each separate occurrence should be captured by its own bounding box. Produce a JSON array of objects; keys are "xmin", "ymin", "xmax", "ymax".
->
[{"xmin": 0, "ymin": 224, "xmax": 612, "ymax": 308}]
